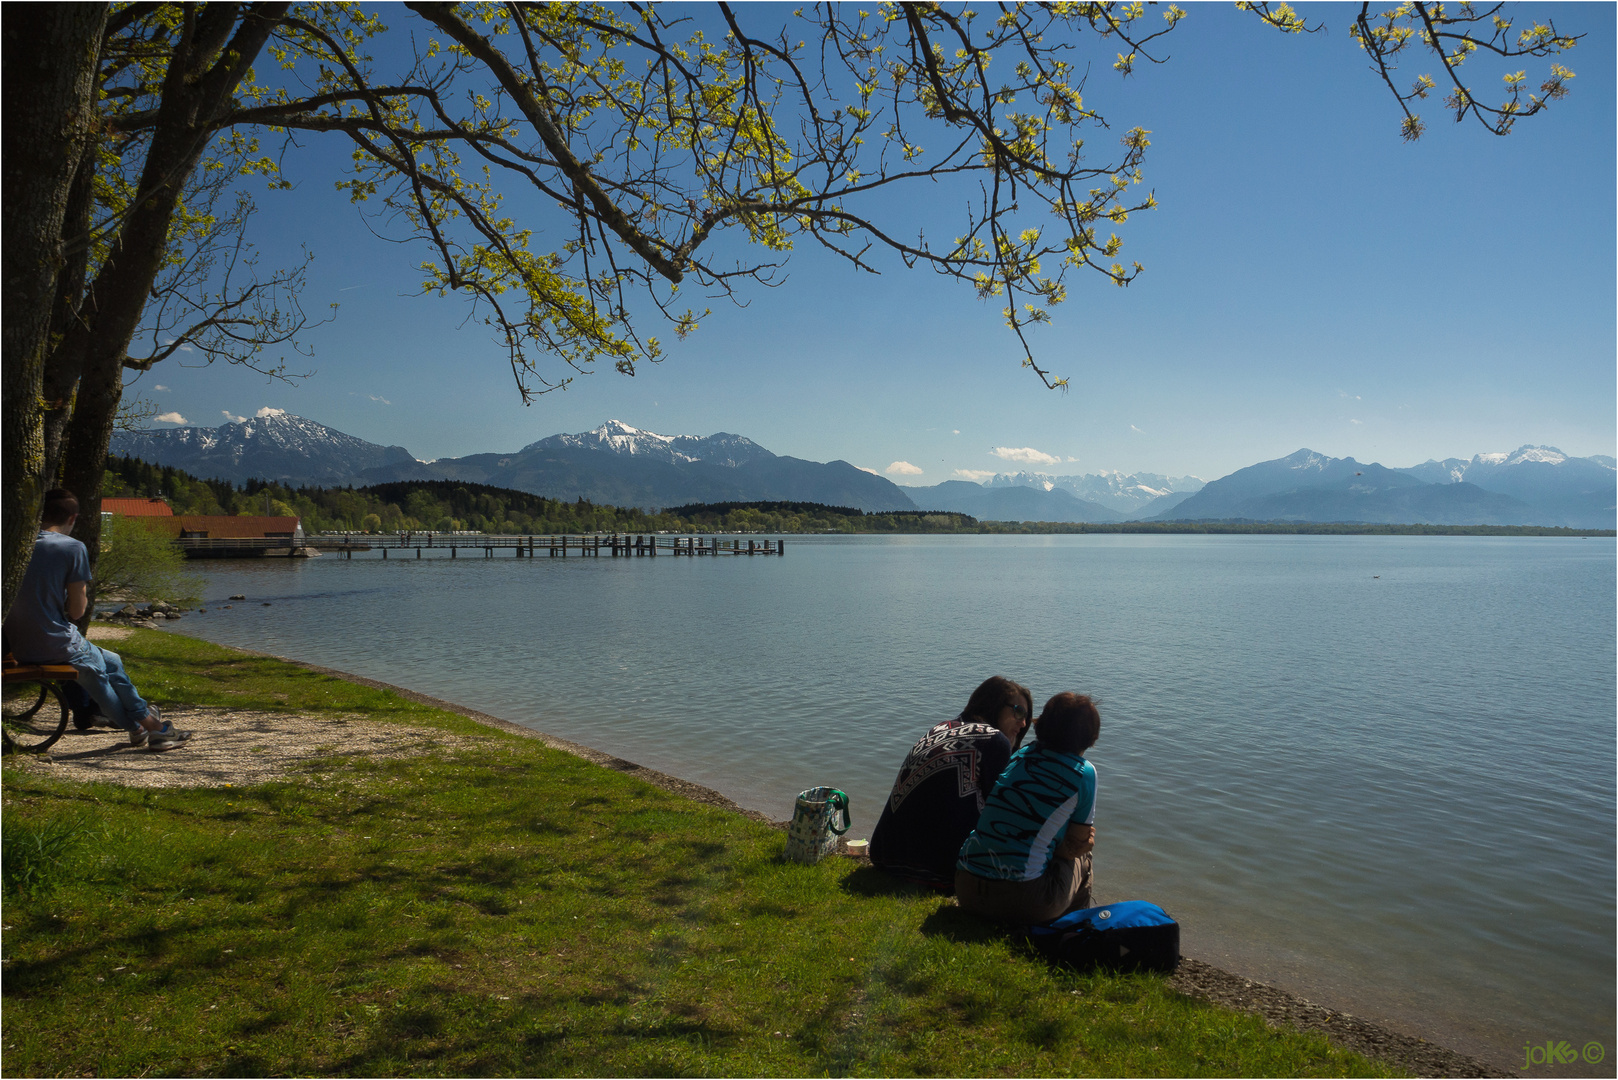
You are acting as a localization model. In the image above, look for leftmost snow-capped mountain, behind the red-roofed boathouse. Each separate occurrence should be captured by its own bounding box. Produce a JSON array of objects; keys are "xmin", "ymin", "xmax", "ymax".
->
[{"xmin": 108, "ymin": 408, "xmax": 416, "ymax": 484}]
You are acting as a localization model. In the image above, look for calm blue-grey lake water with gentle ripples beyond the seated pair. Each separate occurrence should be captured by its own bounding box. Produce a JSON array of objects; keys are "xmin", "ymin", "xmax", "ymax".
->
[{"xmin": 176, "ymin": 536, "xmax": 1618, "ymax": 1070}]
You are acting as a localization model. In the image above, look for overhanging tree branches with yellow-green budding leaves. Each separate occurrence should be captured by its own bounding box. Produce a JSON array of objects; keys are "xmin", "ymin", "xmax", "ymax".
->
[{"xmin": 3, "ymin": 3, "xmax": 1576, "ymax": 615}]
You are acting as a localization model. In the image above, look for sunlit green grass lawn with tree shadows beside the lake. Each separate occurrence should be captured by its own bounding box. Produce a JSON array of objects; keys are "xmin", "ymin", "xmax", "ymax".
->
[{"xmin": 0, "ymin": 631, "xmax": 1388, "ymax": 1075}]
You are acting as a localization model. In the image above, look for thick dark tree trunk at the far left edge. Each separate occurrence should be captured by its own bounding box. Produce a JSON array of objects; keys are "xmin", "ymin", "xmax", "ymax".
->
[{"xmin": 0, "ymin": 3, "xmax": 107, "ymax": 610}]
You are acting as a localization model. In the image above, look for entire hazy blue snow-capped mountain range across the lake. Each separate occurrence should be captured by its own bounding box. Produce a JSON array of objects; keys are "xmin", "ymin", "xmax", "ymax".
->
[{"xmin": 112, "ymin": 410, "xmax": 1618, "ymax": 528}]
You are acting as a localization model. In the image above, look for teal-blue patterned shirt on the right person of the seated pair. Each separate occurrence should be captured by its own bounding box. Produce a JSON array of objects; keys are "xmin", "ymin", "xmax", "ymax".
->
[{"xmin": 955, "ymin": 742, "xmax": 1095, "ymax": 881}]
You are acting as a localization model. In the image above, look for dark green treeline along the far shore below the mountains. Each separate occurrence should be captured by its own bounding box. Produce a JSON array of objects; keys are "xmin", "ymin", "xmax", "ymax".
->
[{"xmin": 102, "ymin": 457, "xmax": 1615, "ymax": 536}]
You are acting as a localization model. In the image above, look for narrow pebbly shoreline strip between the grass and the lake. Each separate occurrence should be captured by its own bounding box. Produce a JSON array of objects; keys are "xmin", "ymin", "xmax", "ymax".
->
[{"xmin": 173, "ymin": 637, "xmax": 1519, "ymax": 1077}]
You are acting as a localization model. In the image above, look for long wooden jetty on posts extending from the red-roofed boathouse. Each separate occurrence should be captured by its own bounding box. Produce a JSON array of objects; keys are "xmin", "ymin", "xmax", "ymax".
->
[{"xmin": 175, "ymin": 531, "xmax": 786, "ymax": 559}]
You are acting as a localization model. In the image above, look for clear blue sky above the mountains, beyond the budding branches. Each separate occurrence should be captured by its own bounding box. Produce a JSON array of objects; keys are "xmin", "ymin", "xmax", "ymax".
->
[{"xmin": 131, "ymin": 5, "xmax": 1618, "ymax": 484}]
